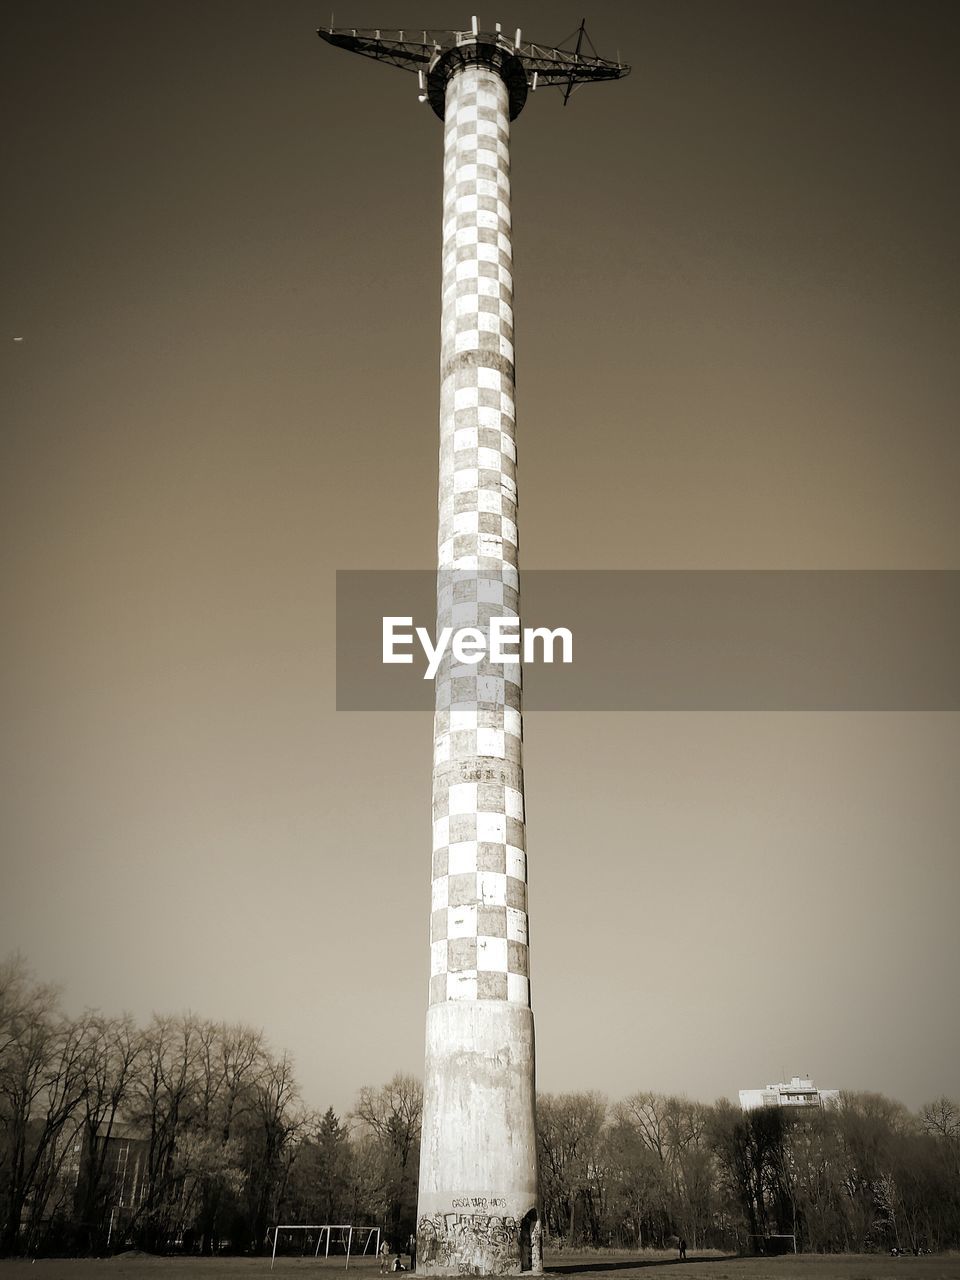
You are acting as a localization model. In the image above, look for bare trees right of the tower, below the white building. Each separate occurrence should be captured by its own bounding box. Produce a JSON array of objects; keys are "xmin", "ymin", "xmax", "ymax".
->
[{"xmin": 538, "ymin": 1093, "xmax": 960, "ymax": 1252}]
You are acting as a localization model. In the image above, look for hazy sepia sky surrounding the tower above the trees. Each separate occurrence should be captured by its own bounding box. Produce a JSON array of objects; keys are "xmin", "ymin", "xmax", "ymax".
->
[{"xmin": 0, "ymin": 0, "xmax": 960, "ymax": 1111}]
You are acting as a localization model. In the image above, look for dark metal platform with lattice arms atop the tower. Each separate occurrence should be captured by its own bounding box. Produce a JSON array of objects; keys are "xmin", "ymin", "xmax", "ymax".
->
[{"xmin": 317, "ymin": 18, "xmax": 630, "ymax": 120}]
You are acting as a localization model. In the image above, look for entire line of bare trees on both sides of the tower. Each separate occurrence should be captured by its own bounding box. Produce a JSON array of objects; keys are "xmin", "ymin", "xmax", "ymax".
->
[{"xmin": 0, "ymin": 956, "xmax": 960, "ymax": 1254}]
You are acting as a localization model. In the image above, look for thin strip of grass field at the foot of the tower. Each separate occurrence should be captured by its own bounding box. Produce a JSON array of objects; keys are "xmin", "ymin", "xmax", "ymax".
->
[{"xmin": 0, "ymin": 1253, "xmax": 960, "ymax": 1280}]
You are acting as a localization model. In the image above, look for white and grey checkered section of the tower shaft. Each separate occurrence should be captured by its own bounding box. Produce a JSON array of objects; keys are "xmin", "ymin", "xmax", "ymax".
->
[{"xmin": 430, "ymin": 65, "xmax": 530, "ymax": 1005}]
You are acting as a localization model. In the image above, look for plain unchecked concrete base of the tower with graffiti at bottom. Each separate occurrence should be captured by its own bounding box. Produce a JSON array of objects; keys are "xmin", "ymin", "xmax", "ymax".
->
[{"xmin": 416, "ymin": 1000, "xmax": 543, "ymax": 1276}]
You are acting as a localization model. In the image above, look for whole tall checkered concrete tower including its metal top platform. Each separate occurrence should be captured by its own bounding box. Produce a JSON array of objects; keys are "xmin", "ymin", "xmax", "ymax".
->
[{"xmin": 319, "ymin": 19, "xmax": 628, "ymax": 1275}]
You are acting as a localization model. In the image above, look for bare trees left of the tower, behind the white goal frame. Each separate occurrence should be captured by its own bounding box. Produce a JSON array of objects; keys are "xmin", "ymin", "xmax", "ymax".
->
[{"xmin": 0, "ymin": 956, "xmax": 422, "ymax": 1256}]
